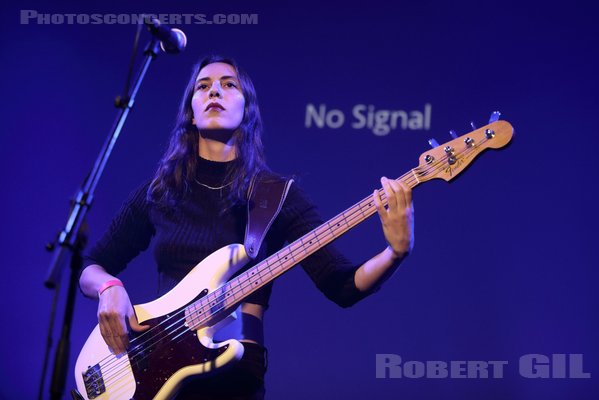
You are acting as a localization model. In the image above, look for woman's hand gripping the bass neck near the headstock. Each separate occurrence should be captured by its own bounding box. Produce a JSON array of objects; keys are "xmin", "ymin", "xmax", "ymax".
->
[{"xmin": 372, "ymin": 177, "xmax": 414, "ymax": 258}]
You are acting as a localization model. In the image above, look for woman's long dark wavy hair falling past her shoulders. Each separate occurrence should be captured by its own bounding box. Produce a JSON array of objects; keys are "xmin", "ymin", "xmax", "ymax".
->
[{"xmin": 148, "ymin": 55, "xmax": 268, "ymax": 207}]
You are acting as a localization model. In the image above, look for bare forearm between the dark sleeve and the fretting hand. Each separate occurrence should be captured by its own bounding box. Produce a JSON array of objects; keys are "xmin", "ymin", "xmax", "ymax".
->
[{"xmin": 354, "ymin": 246, "xmax": 408, "ymax": 292}]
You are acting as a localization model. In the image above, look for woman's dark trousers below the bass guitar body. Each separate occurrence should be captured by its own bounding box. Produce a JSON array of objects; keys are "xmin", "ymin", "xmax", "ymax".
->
[{"xmin": 176, "ymin": 342, "xmax": 267, "ymax": 400}]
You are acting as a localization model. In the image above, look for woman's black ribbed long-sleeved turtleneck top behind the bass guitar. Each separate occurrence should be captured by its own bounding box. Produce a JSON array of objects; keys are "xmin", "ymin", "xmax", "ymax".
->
[{"xmin": 85, "ymin": 158, "xmax": 368, "ymax": 308}]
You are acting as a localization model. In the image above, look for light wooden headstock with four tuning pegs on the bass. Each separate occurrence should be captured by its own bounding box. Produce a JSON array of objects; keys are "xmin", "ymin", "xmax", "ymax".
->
[{"xmin": 414, "ymin": 121, "xmax": 514, "ymax": 182}]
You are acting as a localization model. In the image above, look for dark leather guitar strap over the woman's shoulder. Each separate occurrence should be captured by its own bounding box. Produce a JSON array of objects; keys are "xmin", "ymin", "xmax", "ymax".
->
[{"xmin": 243, "ymin": 172, "xmax": 293, "ymax": 260}]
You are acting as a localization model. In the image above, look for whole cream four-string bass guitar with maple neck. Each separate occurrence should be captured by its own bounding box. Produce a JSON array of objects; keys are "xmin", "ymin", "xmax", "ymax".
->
[{"xmin": 73, "ymin": 117, "xmax": 513, "ymax": 400}]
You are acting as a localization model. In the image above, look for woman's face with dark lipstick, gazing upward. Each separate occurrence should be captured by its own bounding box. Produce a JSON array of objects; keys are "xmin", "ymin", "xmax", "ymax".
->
[{"xmin": 191, "ymin": 63, "xmax": 245, "ymax": 131}]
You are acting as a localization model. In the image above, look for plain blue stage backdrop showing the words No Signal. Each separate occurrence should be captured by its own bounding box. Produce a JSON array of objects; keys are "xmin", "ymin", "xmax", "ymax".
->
[{"xmin": 0, "ymin": 0, "xmax": 599, "ymax": 399}]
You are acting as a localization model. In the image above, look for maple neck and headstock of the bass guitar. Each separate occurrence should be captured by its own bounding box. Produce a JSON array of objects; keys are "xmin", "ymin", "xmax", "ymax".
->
[{"xmin": 186, "ymin": 121, "xmax": 513, "ymax": 329}]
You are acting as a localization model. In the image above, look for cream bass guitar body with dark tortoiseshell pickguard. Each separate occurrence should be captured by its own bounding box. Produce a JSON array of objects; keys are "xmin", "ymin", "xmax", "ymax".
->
[{"xmin": 75, "ymin": 244, "xmax": 248, "ymax": 400}]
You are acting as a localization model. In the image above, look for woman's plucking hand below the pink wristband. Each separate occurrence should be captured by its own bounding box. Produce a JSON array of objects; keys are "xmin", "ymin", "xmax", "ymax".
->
[{"xmin": 98, "ymin": 286, "xmax": 150, "ymax": 355}]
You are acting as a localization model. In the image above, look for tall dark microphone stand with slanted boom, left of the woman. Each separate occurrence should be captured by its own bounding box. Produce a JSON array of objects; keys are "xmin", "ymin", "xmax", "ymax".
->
[{"xmin": 38, "ymin": 37, "xmax": 160, "ymax": 400}]
